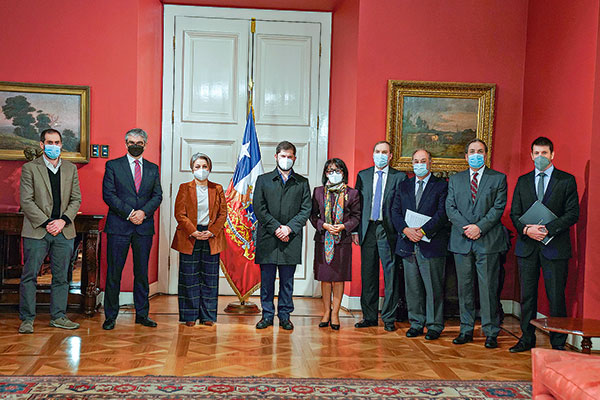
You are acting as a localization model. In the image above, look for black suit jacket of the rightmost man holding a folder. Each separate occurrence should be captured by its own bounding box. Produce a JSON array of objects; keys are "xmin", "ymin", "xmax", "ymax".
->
[{"xmin": 510, "ymin": 167, "xmax": 579, "ymax": 260}]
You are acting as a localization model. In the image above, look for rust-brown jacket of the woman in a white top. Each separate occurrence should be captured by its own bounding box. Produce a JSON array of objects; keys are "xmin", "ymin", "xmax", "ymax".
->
[{"xmin": 171, "ymin": 180, "xmax": 227, "ymax": 255}]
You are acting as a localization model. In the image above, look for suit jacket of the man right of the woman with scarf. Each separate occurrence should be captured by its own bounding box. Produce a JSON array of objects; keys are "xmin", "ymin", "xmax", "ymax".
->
[{"xmin": 356, "ymin": 167, "xmax": 406, "ymax": 249}]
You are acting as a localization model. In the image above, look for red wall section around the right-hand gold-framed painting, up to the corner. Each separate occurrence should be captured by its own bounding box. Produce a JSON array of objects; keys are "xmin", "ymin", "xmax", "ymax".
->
[{"xmin": 329, "ymin": 0, "xmax": 527, "ymax": 297}]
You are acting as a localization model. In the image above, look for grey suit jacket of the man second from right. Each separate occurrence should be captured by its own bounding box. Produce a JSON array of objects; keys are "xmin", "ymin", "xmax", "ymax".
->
[{"xmin": 446, "ymin": 167, "xmax": 508, "ymax": 254}]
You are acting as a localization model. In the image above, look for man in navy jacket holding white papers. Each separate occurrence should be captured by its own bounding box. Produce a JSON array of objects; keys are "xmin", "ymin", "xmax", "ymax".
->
[{"xmin": 392, "ymin": 149, "xmax": 448, "ymax": 340}]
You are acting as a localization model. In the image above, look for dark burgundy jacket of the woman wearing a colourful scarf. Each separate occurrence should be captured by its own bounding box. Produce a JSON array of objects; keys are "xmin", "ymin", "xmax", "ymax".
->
[{"xmin": 310, "ymin": 186, "xmax": 360, "ymax": 243}]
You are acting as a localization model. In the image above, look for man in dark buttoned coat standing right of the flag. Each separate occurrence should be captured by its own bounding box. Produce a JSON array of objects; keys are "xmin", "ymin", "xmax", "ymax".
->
[{"xmin": 253, "ymin": 141, "xmax": 311, "ymax": 330}]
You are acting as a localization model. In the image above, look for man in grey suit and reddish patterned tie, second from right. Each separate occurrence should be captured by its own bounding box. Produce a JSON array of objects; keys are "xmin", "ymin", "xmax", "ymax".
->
[{"xmin": 446, "ymin": 139, "xmax": 508, "ymax": 348}]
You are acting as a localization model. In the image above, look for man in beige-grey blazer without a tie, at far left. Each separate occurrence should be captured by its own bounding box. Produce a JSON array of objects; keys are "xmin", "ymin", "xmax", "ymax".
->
[{"xmin": 19, "ymin": 129, "xmax": 81, "ymax": 333}]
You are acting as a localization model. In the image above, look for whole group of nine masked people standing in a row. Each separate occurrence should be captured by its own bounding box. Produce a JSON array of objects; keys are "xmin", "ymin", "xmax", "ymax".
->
[{"xmin": 19, "ymin": 129, "xmax": 579, "ymax": 352}]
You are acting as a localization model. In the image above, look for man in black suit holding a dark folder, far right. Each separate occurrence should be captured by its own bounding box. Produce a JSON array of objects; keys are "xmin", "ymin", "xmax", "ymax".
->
[{"xmin": 510, "ymin": 136, "xmax": 579, "ymax": 353}]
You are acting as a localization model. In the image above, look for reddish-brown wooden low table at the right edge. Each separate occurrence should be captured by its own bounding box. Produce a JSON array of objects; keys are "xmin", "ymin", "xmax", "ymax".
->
[{"xmin": 531, "ymin": 317, "xmax": 600, "ymax": 354}]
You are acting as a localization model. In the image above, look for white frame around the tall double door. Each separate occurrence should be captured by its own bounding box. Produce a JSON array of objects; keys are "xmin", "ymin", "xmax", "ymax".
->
[{"xmin": 158, "ymin": 5, "xmax": 331, "ymax": 295}]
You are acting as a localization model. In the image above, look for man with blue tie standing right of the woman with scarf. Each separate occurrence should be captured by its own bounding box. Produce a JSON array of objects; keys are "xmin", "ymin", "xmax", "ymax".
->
[{"xmin": 352, "ymin": 141, "xmax": 406, "ymax": 332}]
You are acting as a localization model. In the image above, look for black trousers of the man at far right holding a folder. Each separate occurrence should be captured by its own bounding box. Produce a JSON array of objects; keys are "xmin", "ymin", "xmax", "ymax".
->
[{"xmin": 517, "ymin": 245, "xmax": 569, "ymax": 346}]
